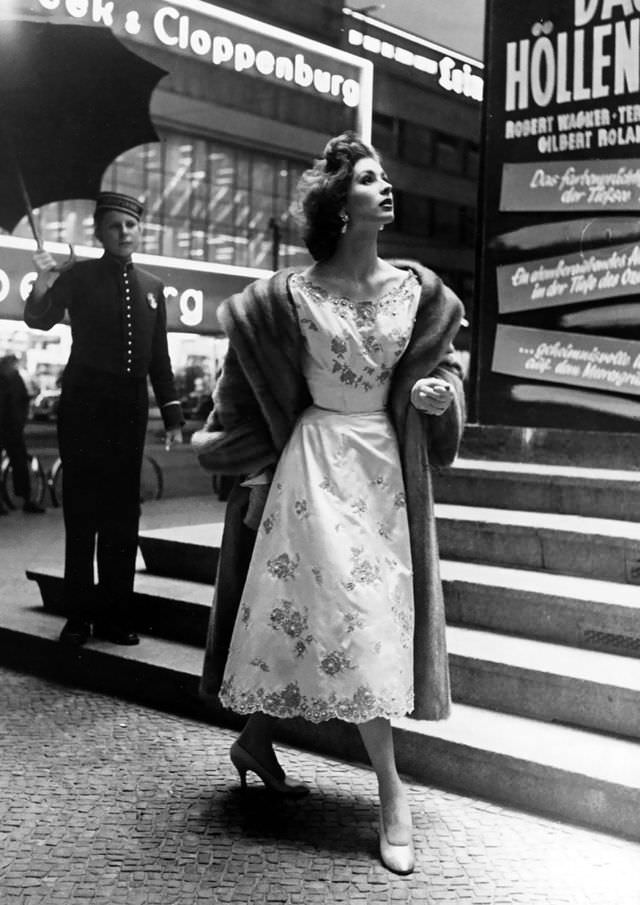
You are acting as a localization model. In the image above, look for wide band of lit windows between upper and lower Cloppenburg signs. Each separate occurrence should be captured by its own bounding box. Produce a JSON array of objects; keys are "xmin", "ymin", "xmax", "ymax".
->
[{"xmin": 16, "ymin": 132, "xmax": 307, "ymax": 268}]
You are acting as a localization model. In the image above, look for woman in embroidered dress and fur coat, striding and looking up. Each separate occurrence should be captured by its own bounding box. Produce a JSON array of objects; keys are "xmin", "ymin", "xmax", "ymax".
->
[{"xmin": 194, "ymin": 133, "xmax": 464, "ymax": 873}]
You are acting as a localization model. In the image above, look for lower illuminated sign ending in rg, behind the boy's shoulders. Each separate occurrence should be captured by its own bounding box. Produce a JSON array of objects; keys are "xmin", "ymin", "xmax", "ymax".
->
[{"xmin": 0, "ymin": 236, "xmax": 271, "ymax": 334}]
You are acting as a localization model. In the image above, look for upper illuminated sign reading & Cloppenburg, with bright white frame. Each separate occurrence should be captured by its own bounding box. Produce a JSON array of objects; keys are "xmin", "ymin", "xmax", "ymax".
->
[{"xmin": 12, "ymin": 0, "xmax": 373, "ymax": 129}]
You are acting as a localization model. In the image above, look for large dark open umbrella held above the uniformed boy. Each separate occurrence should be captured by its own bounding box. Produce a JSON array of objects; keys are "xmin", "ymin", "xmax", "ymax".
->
[{"xmin": 0, "ymin": 19, "xmax": 166, "ymax": 245}]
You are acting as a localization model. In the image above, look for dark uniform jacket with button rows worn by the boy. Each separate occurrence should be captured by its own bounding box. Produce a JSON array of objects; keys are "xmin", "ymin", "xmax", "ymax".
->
[{"xmin": 24, "ymin": 254, "xmax": 181, "ymax": 427}]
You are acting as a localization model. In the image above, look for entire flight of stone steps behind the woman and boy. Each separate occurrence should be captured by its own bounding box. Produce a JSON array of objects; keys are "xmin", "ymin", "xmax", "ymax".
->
[{"xmin": 16, "ymin": 446, "xmax": 640, "ymax": 839}]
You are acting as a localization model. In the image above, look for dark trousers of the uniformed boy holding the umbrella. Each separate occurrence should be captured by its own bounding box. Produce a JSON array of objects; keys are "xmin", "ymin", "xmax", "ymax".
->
[{"xmin": 58, "ymin": 366, "xmax": 148, "ymax": 624}]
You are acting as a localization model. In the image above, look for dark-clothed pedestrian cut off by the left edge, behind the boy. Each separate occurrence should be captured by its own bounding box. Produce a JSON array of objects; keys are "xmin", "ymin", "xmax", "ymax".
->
[{"xmin": 0, "ymin": 355, "xmax": 46, "ymax": 515}]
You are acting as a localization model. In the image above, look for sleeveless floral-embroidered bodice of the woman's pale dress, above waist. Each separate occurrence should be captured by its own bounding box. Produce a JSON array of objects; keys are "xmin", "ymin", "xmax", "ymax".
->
[{"xmin": 289, "ymin": 271, "xmax": 420, "ymax": 412}]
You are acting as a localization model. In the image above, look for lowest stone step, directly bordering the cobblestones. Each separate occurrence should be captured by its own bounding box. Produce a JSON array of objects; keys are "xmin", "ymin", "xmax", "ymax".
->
[{"xmin": 0, "ymin": 607, "xmax": 640, "ymax": 839}]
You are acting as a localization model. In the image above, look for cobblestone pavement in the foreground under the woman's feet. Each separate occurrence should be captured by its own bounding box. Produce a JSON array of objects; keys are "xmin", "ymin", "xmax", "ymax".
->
[{"xmin": 0, "ymin": 667, "xmax": 640, "ymax": 905}]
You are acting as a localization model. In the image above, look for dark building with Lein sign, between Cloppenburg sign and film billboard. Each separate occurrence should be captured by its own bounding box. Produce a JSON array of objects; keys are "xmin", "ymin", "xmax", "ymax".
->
[{"xmin": 343, "ymin": 10, "xmax": 483, "ymax": 313}]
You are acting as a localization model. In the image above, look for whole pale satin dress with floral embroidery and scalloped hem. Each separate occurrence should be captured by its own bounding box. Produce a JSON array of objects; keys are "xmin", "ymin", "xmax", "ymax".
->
[{"xmin": 220, "ymin": 272, "xmax": 420, "ymax": 723}]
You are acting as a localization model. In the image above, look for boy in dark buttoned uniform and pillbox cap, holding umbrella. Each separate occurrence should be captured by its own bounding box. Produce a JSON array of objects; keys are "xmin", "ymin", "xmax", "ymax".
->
[{"xmin": 25, "ymin": 192, "xmax": 183, "ymax": 646}]
